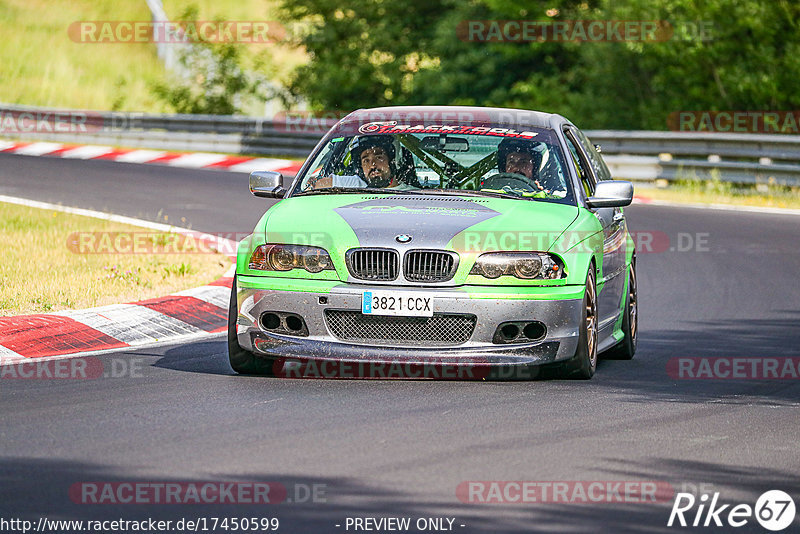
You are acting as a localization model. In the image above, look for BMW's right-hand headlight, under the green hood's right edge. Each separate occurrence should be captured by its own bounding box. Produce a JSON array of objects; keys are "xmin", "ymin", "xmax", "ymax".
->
[{"xmin": 469, "ymin": 252, "xmax": 565, "ymax": 280}]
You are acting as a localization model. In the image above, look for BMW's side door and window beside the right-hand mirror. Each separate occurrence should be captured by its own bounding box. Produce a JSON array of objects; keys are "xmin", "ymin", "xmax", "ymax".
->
[{"xmin": 564, "ymin": 126, "xmax": 627, "ymax": 332}]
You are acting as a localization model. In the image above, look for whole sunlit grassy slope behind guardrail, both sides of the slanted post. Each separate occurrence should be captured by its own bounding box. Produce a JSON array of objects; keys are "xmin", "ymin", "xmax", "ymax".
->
[{"xmin": 0, "ymin": 0, "xmax": 305, "ymax": 114}]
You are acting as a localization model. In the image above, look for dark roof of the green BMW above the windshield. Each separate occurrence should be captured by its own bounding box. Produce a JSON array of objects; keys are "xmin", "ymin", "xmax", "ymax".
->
[{"xmin": 340, "ymin": 106, "xmax": 571, "ymax": 129}]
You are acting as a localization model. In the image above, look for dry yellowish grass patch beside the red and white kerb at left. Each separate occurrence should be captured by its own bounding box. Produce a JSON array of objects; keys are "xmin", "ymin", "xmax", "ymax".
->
[{"xmin": 0, "ymin": 203, "xmax": 231, "ymax": 316}]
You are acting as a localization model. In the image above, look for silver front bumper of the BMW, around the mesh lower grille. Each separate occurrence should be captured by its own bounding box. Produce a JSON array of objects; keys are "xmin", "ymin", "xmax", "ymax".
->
[{"xmin": 236, "ymin": 275, "xmax": 583, "ymax": 366}]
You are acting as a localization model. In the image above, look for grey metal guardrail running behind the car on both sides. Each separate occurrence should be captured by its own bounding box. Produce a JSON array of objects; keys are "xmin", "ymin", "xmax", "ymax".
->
[{"xmin": 0, "ymin": 104, "xmax": 800, "ymax": 186}]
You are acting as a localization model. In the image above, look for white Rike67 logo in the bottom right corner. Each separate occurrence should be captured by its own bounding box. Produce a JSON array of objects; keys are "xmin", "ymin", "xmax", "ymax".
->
[{"xmin": 667, "ymin": 490, "xmax": 795, "ymax": 532}]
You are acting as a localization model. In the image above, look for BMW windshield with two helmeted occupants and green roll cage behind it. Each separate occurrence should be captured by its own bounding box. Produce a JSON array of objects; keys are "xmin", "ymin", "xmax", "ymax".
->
[{"xmin": 292, "ymin": 126, "xmax": 574, "ymax": 204}]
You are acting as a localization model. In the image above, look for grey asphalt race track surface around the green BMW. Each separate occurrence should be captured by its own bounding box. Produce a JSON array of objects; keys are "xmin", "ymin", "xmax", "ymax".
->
[{"xmin": 0, "ymin": 155, "xmax": 800, "ymax": 533}]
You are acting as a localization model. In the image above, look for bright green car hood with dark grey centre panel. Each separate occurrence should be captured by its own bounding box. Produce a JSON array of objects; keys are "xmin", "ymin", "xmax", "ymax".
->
[{"xmin": 261, "ymin": 194, "xmax": 578, "ymax": 255}]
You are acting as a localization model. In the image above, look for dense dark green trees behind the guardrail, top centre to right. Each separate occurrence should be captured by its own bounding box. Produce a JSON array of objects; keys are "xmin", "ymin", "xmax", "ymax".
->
[{"xmin": 283, "ymin": 0, "xmax": 800, "ymax": 129}]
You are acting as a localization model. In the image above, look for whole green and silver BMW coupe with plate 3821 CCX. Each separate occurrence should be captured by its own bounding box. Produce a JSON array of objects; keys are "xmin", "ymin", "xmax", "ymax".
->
[{"xmin": 228, "ymin": 107, "xmax": 637, "ymax": 379}]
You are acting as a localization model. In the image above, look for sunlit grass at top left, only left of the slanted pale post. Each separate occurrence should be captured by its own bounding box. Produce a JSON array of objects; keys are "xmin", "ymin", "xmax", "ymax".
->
[{"xmin": 0, "ymin": 0, "xmax": 164, "ymax": 111}]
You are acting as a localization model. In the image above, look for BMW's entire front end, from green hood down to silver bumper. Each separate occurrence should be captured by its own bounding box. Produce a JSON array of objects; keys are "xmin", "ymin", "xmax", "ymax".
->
[{"xmin": 230, "ymin": 195, "xmax": 591, "ymax": 378}]
